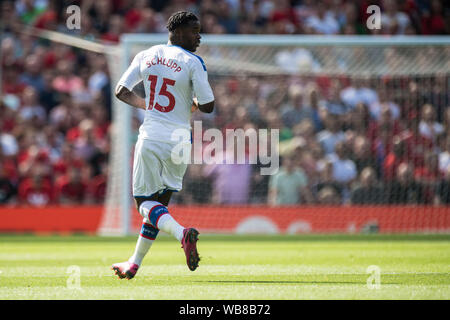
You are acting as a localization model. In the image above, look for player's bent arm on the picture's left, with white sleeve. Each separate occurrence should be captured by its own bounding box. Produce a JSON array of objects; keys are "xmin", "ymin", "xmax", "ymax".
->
[{"xmin": 115, "ymin": 53, "xmax": 146, "ymax": 110}]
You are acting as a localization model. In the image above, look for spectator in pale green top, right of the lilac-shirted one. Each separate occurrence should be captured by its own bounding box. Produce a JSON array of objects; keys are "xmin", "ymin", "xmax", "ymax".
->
[{"xmin": 268, "ymin": 155, "xmax": 311, "ymax": 205}]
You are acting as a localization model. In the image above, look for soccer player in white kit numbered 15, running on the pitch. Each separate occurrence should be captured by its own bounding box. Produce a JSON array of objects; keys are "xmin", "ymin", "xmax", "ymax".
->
[{"xmin": 112, "ymin": 11, "xmax": 214, "ymax": 279}]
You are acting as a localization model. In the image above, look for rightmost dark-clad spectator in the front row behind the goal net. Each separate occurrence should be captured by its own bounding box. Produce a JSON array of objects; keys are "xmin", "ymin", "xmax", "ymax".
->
[{"xmin": 388, "ymin": 163, "xmax": 425, "ymax": 204}]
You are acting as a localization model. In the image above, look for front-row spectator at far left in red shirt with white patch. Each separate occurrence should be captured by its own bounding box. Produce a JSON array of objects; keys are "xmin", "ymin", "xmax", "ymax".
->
[{"xmin": 19, "ymin": 166, "xmax": 55, "ymax": 207}]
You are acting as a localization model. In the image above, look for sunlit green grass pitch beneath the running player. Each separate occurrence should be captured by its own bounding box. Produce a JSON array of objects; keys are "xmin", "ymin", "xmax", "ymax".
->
[{"xmin": 0, "ymin": 235, "xmax": 450, "ymax": 300}]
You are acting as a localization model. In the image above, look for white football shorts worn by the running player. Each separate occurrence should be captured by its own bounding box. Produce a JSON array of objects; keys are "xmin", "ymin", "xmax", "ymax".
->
[{"xmin": 133, "ymin": 139, "xmax": 190, "ymax": 197}]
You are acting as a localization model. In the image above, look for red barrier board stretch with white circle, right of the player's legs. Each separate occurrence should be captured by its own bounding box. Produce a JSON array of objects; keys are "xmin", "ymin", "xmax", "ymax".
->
[{"xmin": 156, "ymin": 206, "xmax": 450, "ymax": 234}]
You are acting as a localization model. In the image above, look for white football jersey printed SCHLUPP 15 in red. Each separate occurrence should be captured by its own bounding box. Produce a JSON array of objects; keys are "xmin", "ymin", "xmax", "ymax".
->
[{"xmin": 118, "ymin": 45, "xmax": 214, "ymax": 143}]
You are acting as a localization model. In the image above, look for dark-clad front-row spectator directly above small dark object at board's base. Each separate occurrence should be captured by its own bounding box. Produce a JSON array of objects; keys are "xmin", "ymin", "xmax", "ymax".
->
[{"xmin": 351, "ymin": 167, "xmax": 386, "ymax": 205}]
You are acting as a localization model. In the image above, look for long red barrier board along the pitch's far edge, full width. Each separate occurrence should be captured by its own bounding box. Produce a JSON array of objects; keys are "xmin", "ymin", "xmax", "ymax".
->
[{"xmin": 0, "ymin": 206, "xmax": 450, "ymax": 234}]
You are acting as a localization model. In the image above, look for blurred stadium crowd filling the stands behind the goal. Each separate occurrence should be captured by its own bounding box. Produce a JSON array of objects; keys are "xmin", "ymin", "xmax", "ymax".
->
[{"xmin": 0, "ymin": 0, "xmax": 450, "ymax": 206}]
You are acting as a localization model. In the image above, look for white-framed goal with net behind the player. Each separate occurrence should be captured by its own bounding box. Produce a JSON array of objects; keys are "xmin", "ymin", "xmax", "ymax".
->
[{"xmin": 99, "ymin": 34, "xmax": 450, "ymax": 235}]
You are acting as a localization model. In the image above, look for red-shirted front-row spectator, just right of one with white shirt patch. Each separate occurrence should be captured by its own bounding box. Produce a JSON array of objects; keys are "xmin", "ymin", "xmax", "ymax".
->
[{"xmin": 56, "ymin": 167, "xmax": 87, "ymax": 204}]
